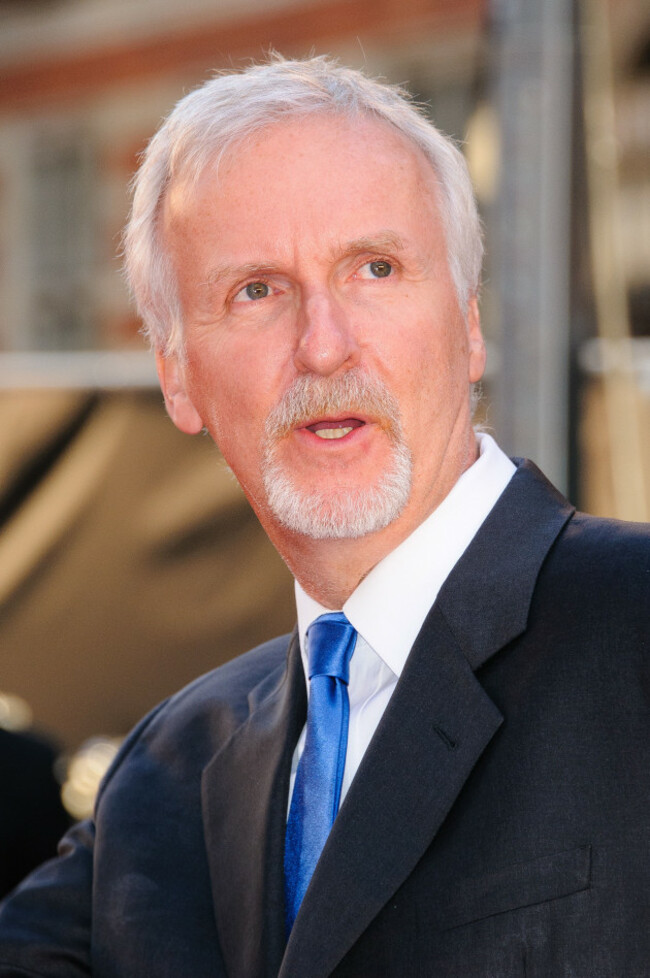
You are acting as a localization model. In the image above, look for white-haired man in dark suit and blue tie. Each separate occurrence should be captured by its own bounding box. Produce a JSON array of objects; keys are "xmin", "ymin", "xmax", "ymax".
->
[{"xmin": 0, "ymin": 58, "xmax": 650, "ymax": 978}]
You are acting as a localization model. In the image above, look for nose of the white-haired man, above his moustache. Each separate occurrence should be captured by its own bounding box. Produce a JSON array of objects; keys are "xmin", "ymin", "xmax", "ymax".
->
[{"xmin": 295, "ymin": 291, "xmax": 358, "ymax": 375}]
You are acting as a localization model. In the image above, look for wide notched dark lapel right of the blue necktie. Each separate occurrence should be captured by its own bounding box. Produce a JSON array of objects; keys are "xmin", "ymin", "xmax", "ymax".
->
[{"xmin": 279, "ymin": 463, "xmax": 573, "ymax": 978}]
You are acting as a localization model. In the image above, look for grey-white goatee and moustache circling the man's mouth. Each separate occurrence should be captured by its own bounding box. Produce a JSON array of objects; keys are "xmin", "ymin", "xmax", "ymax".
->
[{"xmin": 262, "ymin": 371, "xmax": 413, "ymax": 540}]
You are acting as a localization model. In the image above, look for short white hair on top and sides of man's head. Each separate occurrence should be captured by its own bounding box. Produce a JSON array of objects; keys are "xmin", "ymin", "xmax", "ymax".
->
[{"xmin": 123, "ymin": 55, "xmax": 483, "ymax": 354}]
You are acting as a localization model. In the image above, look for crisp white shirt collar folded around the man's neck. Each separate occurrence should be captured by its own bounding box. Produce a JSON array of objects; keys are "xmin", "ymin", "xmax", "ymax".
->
[{"xmin": 295, "ymin": 432, "xmax": 515, "ymax": 676}]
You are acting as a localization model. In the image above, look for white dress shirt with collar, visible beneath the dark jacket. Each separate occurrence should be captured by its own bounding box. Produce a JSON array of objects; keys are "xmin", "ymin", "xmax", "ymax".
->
[{"xmin": 289, "ymin": 433, "xmax": 515, "ymax": 802}]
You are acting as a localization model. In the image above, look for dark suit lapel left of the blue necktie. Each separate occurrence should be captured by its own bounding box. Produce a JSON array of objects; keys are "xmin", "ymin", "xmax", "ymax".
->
[{"xmin": 202, "ymin": 634, "xmax": 306, "ymax": 978}]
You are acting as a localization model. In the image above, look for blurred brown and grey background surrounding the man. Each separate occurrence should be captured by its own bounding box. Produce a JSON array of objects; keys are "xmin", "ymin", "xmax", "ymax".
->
[{"xmin": 0, "ymin": 0, "xmax": 650, "ymax": 832}]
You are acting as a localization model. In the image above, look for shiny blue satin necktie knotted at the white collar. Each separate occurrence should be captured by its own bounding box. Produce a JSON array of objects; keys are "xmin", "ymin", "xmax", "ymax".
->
[{"xmin": 284, "ymin": 612, "xmax": 357, "ymax": 934}]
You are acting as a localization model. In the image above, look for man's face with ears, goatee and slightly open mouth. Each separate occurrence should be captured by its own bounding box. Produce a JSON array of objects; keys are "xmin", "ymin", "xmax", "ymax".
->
[{"xmin": 159, "ymin": 115, "xmax": 484, "ymax": 543}]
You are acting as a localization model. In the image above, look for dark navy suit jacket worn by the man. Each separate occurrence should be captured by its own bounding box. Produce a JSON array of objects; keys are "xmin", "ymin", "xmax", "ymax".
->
[{"xmin": 0, "ymin": 465, "xmax": 650, "ymax": 978}]
